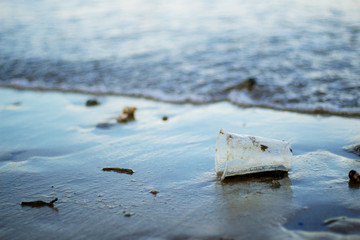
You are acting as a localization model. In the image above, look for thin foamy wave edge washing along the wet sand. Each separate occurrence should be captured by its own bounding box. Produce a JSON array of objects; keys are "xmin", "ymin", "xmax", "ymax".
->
[{"xmin": 0, "ymin": 79, "xmax": 360, "ymax": 117}]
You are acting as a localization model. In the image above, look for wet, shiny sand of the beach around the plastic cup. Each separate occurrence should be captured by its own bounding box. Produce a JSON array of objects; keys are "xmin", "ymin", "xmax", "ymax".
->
[{"xmin": 0, "ymin": 88, "xmax": 360, "ymax": 239}]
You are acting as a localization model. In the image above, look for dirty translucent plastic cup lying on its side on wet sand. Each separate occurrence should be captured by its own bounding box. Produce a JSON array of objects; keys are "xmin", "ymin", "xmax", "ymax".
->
[{"xmin": 215, "ymin": 129, "xmax": 293, "ymax": 180}]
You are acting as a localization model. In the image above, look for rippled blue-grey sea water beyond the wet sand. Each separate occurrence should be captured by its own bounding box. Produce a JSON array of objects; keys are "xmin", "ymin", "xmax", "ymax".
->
[{"xmin": 0, "ymin": 0, "xmax": 360, "ymax": 115}]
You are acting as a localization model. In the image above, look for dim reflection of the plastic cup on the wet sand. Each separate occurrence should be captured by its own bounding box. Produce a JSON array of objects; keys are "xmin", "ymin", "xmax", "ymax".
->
[{"xmin": 215, "ymin": 174, "xmax": 293, "ymax": 238}]
